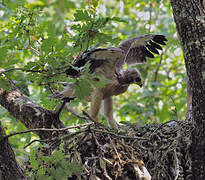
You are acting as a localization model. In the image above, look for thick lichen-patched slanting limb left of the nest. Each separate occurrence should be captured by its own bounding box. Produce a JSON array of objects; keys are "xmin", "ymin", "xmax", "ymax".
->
[{"xmin": 0, "ymin": 89, "xmax": 64, "ymax": 139}]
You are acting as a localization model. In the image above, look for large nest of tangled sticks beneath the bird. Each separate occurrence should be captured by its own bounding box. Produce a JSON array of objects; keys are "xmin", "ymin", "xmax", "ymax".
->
[{"xmin": 43, "ymin": 116, "xmax": 192, "ymax": 180}]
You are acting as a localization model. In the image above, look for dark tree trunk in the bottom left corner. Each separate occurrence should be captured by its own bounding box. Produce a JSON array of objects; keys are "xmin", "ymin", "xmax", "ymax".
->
[{"xmin": 0, "ymin": 123, "xmax": 26, "ymax": 180}]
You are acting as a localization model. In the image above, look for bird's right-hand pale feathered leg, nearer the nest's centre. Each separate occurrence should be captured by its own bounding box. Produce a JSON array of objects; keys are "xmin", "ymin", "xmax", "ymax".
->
[{"xmin": 104, "ymin": 96, "xmax": 118, "ymax": 129}]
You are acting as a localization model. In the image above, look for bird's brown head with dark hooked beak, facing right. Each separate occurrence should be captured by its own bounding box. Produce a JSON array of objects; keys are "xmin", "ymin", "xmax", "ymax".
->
[{"xmin": 121, "ymin": 69, "xmax": 142, "ymax": 87}]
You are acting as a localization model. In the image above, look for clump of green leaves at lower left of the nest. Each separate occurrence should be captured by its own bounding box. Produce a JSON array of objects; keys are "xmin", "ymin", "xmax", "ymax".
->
[{"xmin": 28, "ymin": 146, "xmax": 82, "ymax": 180}]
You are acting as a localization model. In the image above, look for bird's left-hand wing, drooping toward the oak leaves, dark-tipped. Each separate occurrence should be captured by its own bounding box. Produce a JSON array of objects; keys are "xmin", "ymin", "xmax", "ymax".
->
[{"xmin": 66, "ymin": 47, "xmax": 125, "ymax": 80}]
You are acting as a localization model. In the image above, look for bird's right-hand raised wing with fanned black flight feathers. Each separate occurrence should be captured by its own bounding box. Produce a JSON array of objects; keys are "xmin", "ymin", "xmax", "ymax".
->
[{"xmin": 118, "ymin": 34, "xmax": 167, "ymax": 66}]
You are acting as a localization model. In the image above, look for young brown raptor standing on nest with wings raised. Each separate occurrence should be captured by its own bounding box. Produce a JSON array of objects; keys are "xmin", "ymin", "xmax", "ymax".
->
[{"xmin": 61, "ymin": 34, "xmax": 167, "ymax": 128}]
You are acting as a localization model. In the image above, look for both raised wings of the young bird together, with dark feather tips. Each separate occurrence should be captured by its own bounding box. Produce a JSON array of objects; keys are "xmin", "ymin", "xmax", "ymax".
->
[{"xmin": 66, "ymin": 34, "xmax": 167, "ymax": 81}]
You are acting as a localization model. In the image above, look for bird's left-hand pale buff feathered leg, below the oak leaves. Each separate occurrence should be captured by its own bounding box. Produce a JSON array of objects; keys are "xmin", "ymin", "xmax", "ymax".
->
[{"xmin": 90, "ymin": 89, "xmax": 103, "ymax": 121}]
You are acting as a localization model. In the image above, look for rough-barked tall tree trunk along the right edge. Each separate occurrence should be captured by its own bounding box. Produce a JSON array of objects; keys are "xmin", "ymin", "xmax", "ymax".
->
[{"xmin": 171, "ymin": 0, "xmax": 205, "ymax": 179}]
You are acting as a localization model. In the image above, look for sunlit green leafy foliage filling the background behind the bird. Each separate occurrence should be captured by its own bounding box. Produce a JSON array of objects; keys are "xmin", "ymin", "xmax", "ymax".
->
[{"xmin": 0, "ymin": 0, "xmax": 186, "ymax": 177}]
